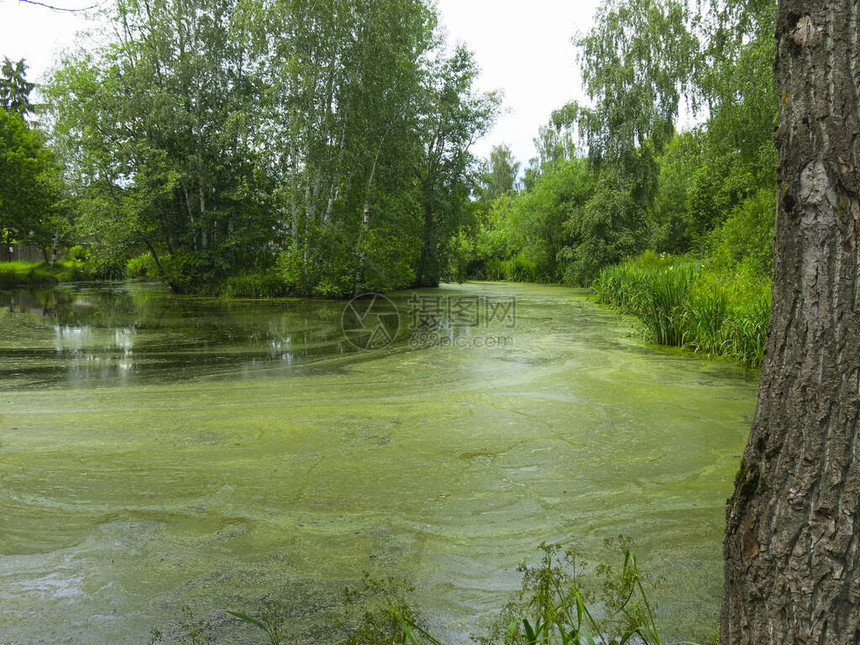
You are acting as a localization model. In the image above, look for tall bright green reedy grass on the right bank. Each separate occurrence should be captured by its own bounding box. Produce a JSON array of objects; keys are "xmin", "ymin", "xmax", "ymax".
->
[{"xmin": 593, "ymin": 253, "xmax": 770, "ymax": 366}]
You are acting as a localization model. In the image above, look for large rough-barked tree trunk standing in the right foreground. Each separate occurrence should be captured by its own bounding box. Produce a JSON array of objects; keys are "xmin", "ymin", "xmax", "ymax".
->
[{"xmin": 721, "ymin": 0, "xmax": 860, "ymax": 645}]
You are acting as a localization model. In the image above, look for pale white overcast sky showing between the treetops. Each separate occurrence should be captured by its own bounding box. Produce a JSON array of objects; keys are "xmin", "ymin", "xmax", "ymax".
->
[{"xmin": 0, "ymin": 0, "xmax": 598, "ymax": 165}]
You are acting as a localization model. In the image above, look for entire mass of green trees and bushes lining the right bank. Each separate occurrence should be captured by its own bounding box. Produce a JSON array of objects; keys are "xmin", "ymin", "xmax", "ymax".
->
[{"xmin": 464, "ymin": 0, "xmax": 776, "ymax": 285}]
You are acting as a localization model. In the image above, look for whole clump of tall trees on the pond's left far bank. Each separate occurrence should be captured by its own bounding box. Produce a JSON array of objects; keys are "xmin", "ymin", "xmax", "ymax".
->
[{"xmin": 49, "ymin": 0, "xmax": 497, "ymax": 295}]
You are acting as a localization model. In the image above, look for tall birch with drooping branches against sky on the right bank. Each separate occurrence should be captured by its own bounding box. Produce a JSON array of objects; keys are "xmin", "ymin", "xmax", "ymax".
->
[{"xmin": 553, "ymin": 0, "xmax": 699, "ymax": 284}]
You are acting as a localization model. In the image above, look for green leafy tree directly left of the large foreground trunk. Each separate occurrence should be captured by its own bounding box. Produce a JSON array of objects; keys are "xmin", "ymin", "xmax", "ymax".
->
[{"xmin": 688, "ymin": 0, "xmax": 778, "ymax": 268}]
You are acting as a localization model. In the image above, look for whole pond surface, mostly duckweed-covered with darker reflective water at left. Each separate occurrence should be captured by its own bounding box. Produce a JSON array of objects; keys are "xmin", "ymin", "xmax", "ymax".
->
[{"xmin": 0, "ymin": 284, "xmax": 757, "ymax": 644}]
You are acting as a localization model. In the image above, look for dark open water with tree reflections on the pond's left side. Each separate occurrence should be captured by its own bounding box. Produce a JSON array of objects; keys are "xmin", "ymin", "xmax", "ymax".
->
[{"xmin": 0, "ymin": 285, "xmax": 355, "ymax": 387}]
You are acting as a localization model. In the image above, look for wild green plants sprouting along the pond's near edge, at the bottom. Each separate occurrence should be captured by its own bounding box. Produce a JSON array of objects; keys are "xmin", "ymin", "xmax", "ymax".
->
[{"xmin": 170, "ymin": 538, "xmax": 704, "ymax": 645}]
